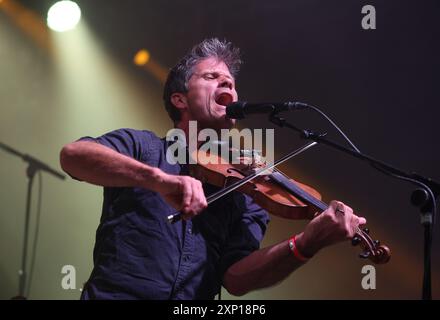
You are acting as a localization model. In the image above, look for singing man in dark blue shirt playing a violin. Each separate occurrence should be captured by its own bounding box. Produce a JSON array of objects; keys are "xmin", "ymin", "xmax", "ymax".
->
[{"xmin": 60, "ymin": 39, "xmax": 366, "ymax": 299}]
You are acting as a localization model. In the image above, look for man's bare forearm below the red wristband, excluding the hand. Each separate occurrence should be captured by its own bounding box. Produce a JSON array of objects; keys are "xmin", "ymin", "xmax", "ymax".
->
[{"xmin": 223, "ymin": 234, "xmax": 303, "ymax": 295}]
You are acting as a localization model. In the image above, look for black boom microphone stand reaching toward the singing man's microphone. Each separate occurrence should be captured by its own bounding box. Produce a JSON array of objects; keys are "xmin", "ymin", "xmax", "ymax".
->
[{"xmin": 269, "ymin": 112, "xmax": 440, "ymax": 300}]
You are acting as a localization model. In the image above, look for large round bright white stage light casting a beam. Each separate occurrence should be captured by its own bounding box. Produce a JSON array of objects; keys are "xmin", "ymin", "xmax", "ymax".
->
[{"xmin": 47, "ymin": 0, "xmax": 81, "ymax": 32}]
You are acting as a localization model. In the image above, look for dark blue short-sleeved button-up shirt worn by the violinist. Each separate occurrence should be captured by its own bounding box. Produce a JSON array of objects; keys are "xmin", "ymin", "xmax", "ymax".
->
[{"xmin": 81, "ymin": 129, "xmax": 269, "ymax": 299}]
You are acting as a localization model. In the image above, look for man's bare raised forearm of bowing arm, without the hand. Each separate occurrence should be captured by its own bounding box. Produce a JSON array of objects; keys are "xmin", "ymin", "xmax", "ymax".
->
[{"xmin": 60, "ymin": 141, "xmax": 160, "ymax": 190}]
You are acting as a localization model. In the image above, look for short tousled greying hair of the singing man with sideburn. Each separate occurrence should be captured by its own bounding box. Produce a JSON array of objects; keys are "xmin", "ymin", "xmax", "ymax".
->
[{"xmin": 163, "ymin": 38, "xmax": 242, "ymax": 124}]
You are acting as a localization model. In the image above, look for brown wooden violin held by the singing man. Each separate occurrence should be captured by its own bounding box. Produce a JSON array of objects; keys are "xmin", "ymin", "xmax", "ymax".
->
[{"xmin": 168, "ymin": 145, "xmax": 391, "ymax": 264}]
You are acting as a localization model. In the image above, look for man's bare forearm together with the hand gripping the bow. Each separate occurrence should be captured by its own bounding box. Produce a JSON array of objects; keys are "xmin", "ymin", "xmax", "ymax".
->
[{"xmin": 60, "ymin": 141, "xmax": 207, "ymax": 219}]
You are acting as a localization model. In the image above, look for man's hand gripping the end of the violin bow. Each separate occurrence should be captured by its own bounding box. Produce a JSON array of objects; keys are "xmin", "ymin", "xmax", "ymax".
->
[{"xmin": 155, "ymin": 171, "xmax": 208, "ymax": 220}]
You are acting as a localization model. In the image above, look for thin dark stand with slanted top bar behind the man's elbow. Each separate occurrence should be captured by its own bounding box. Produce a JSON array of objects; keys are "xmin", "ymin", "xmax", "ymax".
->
[{"xmin": 0, "ymin": 142, "xmax": 66, "ymax": 300}]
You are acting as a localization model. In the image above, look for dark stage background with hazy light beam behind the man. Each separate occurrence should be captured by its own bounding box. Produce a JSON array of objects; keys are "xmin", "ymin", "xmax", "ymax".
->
[{"xmin": 0, "ymin": 0, "xmax": 440, "ymax": 299}]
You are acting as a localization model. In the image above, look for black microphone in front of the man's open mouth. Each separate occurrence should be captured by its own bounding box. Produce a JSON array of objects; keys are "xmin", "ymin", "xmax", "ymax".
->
[{"xmin": 226, "ymin": 101, "xmax": 309, "ymax": 119}]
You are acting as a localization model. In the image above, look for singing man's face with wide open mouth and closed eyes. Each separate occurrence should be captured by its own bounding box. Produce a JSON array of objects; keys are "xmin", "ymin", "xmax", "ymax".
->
[{"xmin": 186, "ymin": 58, "xmax": 238, "ymax": 130}]
